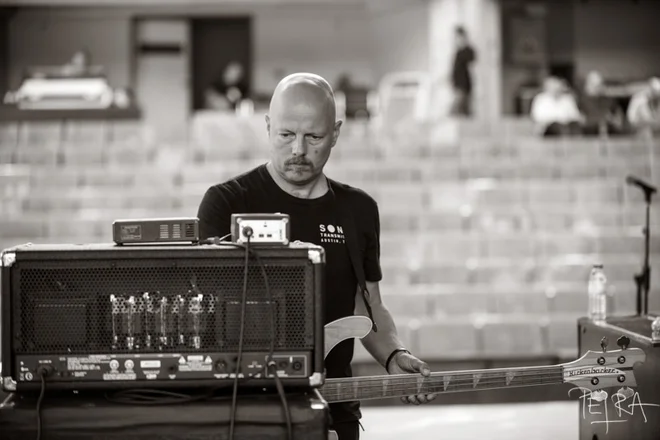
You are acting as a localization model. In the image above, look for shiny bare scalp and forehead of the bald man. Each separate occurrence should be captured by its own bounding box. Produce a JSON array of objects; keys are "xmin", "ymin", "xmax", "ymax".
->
[{"xmin": 268, "ymin": 73, "xmax": 336, "ymax": 124}]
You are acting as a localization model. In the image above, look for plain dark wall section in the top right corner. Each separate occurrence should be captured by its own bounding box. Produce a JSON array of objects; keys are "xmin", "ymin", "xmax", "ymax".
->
[{"xmin": 575, "ymin": 0, "xmax": 660, "ymax": 80}]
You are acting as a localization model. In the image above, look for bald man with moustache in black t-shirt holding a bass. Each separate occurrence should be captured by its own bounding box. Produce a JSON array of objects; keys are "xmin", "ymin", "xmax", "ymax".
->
[{"xmin": 198, "ymin": 73, "xmax": 435, "ymax": 440}]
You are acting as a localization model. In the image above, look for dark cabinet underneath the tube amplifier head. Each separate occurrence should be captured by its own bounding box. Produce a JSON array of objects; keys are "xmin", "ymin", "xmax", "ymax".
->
[{"xmin": 0, "ymin": 390, "xmax": 329, "ymax": 440}]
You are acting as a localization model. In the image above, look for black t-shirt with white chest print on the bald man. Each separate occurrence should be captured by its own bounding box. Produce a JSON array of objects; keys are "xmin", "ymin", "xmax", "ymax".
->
[{"xmin": 197, "ymin": 165, "xmax": 382, "ymax": 422}]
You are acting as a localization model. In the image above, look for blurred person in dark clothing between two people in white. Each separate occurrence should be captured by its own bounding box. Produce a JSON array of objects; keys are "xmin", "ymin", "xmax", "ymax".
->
[{"xmin": 579, "ymin": 71, "xmax": 624, "ymax": 136}]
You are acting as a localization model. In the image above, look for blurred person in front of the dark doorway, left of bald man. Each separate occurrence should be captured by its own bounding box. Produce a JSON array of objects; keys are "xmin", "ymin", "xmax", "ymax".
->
[{"xmin": 205, "ymin": 61, "xmax": 248, "ymax": 113}]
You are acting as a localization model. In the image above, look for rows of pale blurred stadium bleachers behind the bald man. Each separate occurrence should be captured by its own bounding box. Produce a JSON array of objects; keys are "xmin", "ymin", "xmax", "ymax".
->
[{"xmin": 0, "ymin": 116, "xmax": 660, "ymax": 363}]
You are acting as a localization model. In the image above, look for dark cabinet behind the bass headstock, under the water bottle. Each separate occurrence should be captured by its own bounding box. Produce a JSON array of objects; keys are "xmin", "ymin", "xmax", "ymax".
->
[{"xmin": 571, "ymin": 316, "xmax": 660, "ymax": 440}]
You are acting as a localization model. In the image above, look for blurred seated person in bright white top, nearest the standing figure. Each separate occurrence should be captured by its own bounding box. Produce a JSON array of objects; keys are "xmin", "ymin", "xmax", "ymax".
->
[{"xmin": 531, "ymin": 77, "xmax": 583, "ymax": 137}]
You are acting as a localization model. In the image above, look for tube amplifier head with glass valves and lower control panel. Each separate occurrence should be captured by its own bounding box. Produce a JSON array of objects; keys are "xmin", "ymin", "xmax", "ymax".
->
[{"xmin": 2, "ymin": 244, "xmax": 325, "ymax": 391}]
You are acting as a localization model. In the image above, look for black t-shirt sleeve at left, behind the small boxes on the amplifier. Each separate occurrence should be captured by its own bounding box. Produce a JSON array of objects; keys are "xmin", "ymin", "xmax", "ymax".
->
[{"xmin": 197, "ymin": 185, "xmax": 241, "ymax": 240}]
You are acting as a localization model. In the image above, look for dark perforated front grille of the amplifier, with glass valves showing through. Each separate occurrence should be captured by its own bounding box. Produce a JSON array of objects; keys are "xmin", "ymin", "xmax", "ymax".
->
[{"xmin": 12, "ymin": 258, "xmax": 314, "ymax": 354}]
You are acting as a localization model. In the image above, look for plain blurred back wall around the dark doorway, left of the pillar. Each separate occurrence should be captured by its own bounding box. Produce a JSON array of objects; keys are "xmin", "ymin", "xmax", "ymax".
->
[{"xmin": 10, "ymin": 3, "xmax": 428, "ymax": 97}]
